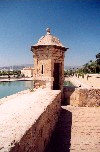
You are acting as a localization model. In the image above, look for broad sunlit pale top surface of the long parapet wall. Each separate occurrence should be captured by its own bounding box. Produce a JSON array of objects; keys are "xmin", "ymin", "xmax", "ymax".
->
[{"xmin": 0, "ymin": 88, "xmax": 61, "ymax": 152}]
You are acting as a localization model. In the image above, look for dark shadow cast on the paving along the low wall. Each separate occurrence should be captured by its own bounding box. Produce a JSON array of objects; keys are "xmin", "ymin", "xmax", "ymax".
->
[{"xmin": 45, "ymin": 108, "xmax": 72, "ymax": 152}]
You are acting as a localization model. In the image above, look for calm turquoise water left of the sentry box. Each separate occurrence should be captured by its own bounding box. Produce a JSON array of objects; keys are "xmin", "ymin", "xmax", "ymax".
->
[{"xmin": 0, "ymin": 81, "xmax": 34, "ymax": 98}]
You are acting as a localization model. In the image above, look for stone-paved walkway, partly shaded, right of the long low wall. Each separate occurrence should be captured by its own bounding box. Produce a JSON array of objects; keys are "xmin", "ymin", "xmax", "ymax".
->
[{"xmin": 46, "ymin": 106, "xmax": 100, "ymax": 152}]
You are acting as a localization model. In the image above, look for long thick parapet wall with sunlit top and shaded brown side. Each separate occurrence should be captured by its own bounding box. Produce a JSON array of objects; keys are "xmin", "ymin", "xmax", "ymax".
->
[{"xmin": 0, "ymin": 89, "xmax": 61, "ymax": 152}]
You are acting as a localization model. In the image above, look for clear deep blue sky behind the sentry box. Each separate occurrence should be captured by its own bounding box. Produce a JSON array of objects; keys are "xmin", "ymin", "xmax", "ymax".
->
[{"xmin": 0, "ymin": 0, "xmax": 100, "ymax": 66}]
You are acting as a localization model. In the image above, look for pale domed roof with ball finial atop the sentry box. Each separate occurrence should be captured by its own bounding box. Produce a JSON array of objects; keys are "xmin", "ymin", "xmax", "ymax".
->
[{"xmin": 34, "ymin": 28, "xmax": 64, "ymax": 47}]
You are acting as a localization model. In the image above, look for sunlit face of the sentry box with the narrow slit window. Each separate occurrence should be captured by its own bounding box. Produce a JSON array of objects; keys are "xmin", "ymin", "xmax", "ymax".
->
[{"xmin": 33, "ymin": 47, "xmax": 52, "ymax": 78}]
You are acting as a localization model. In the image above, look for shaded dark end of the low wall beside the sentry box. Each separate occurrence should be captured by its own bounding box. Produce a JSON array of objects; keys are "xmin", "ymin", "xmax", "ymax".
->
[{"xmin": 61, "ymin": 86, "xmax": 77, "ymax": 106}]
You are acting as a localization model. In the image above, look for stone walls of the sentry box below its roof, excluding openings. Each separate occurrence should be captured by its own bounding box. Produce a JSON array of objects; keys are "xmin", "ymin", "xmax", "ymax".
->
[{"xmin": 33, "ymin": 46, "xmax": 64, "ymax": 89}]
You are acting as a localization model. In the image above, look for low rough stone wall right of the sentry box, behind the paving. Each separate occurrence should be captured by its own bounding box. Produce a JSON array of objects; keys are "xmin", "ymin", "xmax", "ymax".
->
[{"xmin": 63, "ymin": 87, "xmax": 100, "ymax": 107}]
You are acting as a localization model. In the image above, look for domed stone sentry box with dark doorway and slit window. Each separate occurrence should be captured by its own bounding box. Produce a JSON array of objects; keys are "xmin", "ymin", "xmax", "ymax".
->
[{"xmin": 31, "ymin": 28, "xmax": 68, "ymax": 90}]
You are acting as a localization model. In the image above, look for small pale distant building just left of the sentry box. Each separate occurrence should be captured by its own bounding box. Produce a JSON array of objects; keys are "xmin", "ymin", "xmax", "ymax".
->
[{"xmin": 21, "ymin": 67, "xmax": 34, "ymax": 77}]
